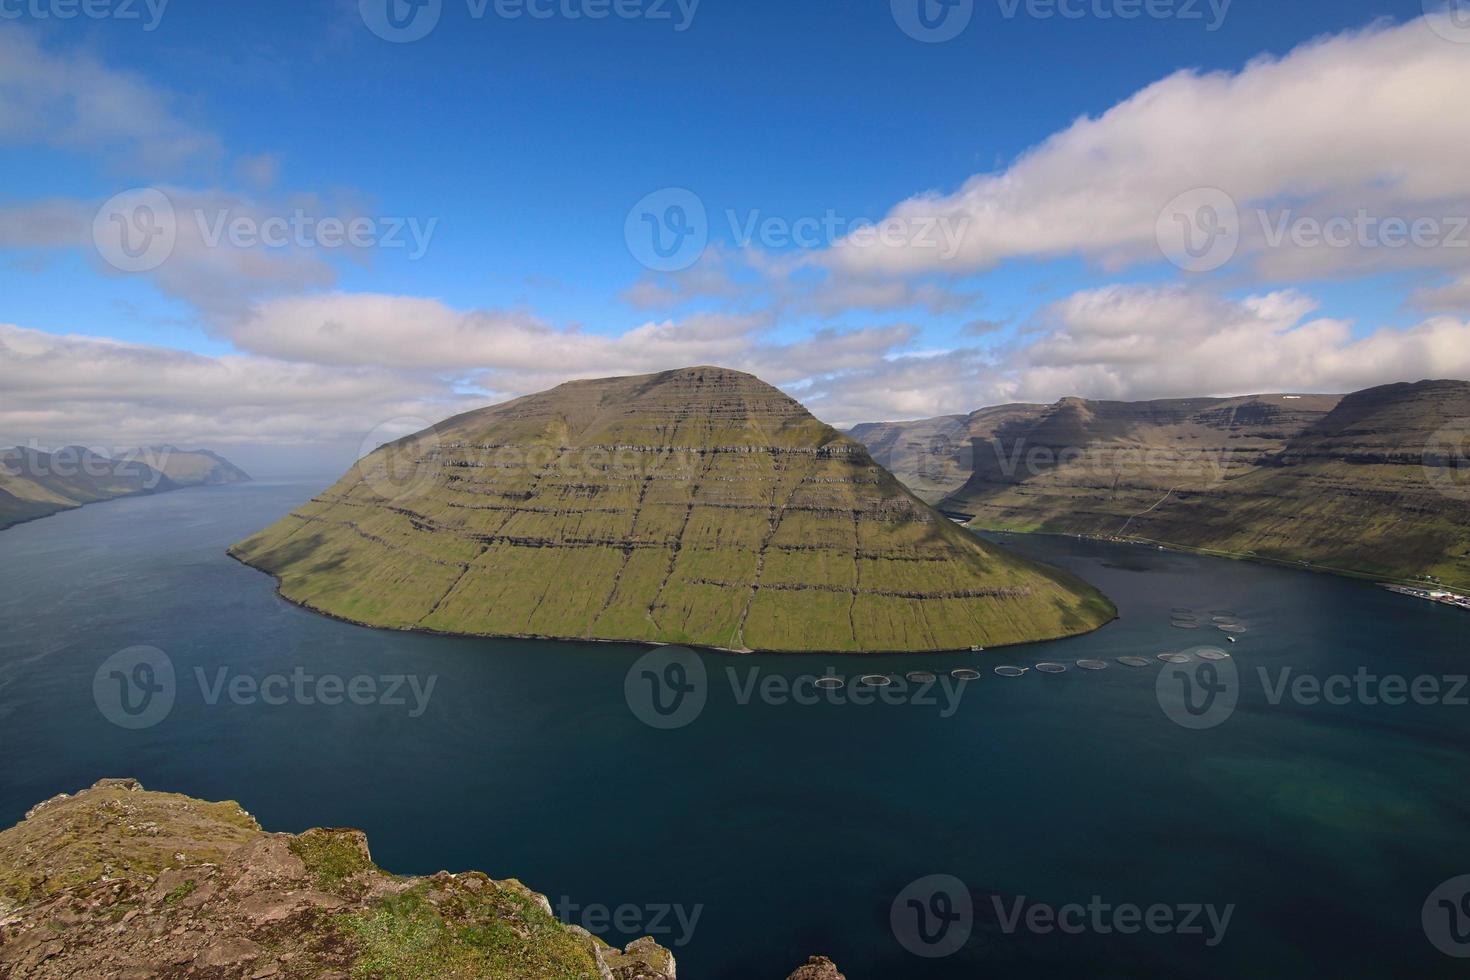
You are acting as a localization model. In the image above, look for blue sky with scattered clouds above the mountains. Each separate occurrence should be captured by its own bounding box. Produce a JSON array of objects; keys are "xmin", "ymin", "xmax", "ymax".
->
[{"xmin": 0, "ymin": 0, "xmax": 1470, "ymax": 470}]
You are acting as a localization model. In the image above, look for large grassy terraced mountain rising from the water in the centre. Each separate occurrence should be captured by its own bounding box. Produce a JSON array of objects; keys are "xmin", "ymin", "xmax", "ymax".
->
[{"xmin": 231, "ymin": 367, "xmax": 1114, "ymax": 652}]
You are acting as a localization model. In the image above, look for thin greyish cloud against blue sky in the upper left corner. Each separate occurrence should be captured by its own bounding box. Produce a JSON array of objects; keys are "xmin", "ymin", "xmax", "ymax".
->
[{"xmin": 0, "ymin": 24, "xmax": 222, "ymax": 172}]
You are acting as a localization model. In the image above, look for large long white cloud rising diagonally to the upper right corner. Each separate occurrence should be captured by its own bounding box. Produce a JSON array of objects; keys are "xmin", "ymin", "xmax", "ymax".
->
[{"xmin": 823, "ymin": 19, "xmax": 1470, "ymax": 283}]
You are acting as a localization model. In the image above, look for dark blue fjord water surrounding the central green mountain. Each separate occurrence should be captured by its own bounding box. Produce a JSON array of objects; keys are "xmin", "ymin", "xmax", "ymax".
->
[{"xmin": 0, "ymin": 480, "xmax": 1470, "ymax": 980}]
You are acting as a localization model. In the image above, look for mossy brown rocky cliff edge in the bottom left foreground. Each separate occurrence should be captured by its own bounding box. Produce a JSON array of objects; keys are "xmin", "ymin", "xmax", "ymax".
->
[{"xmin": 0, "ymin": 779, "xmax": 841, "ymax": 980}]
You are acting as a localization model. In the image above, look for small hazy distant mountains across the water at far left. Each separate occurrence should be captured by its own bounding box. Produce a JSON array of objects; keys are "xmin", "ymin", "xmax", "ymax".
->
[{"xmin": 0, "ymin": 445, "xmax": 250, "ymax": 527}]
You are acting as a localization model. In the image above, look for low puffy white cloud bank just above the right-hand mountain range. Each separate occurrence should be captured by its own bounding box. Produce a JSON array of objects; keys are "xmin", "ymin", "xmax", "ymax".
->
[{"xmin": 801, "ymin": 285, "xmax": 1470, "ymax": 425}]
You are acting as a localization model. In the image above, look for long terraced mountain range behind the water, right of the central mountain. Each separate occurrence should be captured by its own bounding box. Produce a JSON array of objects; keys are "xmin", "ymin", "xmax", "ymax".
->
[{"xmin": 851, "ymin": 381, "xmax": 1470, "ymax": 588}]
